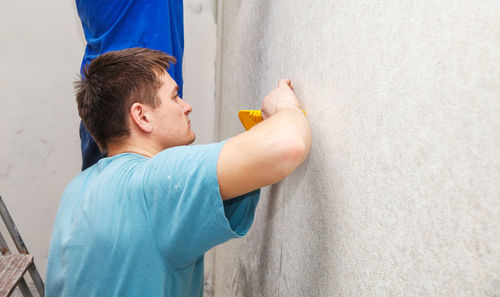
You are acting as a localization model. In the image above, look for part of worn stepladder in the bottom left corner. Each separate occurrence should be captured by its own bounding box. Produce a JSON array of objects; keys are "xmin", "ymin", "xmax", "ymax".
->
[{"xmin": 0, "ymin": 196, "xmax": 45, "ymax": 297}]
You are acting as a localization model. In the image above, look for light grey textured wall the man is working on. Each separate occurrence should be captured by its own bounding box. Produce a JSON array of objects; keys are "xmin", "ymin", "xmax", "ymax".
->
[{"xmin": 207, "ymin": 0, "xmax": 500, "ymax": 296}]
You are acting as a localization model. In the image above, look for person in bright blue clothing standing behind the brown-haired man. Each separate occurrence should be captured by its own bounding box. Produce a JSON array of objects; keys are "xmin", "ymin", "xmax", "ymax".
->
[{"xmin": 76, "ymin": 0, "xmax": 184, "ymax": 170}]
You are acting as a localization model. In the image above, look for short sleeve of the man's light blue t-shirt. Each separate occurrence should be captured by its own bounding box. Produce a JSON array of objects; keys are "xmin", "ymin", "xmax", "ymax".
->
[{"xmin": 140, "ymin": 142, "xmax": 260, "ymax": 268}]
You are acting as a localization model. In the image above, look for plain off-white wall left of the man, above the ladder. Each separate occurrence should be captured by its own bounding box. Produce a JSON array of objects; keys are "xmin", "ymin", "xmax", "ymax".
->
[{"xmin": 0, "ymin": 0, "xmax": 84, "ymax": 276}]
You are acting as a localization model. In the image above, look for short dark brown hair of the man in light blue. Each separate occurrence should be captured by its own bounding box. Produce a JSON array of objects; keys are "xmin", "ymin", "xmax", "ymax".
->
[{"xmin": 75, "ymin": 48, "xmax": 175, "ymax": 151}]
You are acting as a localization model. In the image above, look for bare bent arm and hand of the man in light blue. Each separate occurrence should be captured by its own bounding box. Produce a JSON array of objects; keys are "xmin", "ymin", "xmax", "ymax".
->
[{"xmin": 217, "ymin": 80, "xmax": 311, "ymax": 200}]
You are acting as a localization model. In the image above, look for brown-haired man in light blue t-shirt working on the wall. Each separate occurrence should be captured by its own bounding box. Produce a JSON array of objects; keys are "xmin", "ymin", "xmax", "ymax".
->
[{"xmin": 46, "ymin": 48, "xmax": 311, "ymax": 297}]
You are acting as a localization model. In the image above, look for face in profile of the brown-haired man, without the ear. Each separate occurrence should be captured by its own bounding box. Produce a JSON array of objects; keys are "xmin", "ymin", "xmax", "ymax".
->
[{"xmin": 153, "ymin": 71, "xmax": 195, "ymax": 149}]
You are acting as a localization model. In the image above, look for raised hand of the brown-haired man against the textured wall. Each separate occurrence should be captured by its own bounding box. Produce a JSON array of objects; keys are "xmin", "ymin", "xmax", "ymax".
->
[{"xmin": 261, "ymin": 79, "xmax": 300, "ymax": 119}]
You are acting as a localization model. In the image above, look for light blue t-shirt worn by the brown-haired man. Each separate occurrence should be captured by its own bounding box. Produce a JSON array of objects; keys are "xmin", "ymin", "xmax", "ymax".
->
[{"xmin": 46, "ymin": 142, "xmax": 260, "ymax": 297}]
